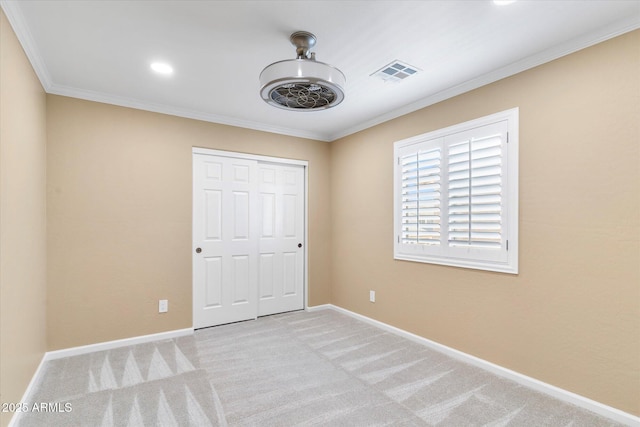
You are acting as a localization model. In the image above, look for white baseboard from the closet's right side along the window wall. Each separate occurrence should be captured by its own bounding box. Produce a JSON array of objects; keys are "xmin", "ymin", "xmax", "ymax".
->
[{"xmin": 322, "ymin": 304, "xmax": 640, "ymax": 426}]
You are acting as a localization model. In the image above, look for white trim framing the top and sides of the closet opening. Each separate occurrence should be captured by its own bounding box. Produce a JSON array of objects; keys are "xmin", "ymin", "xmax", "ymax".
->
[{"xmin": 191, "ymin": 147, "xmax": 309, "ymax": 328}]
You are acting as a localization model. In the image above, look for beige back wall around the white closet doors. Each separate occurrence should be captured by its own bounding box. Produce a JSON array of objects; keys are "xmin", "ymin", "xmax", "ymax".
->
[{"xmin": 47, "ymin": 95, "xmax": 330, "ymax": 350}]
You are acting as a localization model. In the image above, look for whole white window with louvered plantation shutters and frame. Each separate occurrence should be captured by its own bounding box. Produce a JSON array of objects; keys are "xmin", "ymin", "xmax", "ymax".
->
[{"xmin": 394, "ymin": 108, "xmax": 518, "ymax": 274}]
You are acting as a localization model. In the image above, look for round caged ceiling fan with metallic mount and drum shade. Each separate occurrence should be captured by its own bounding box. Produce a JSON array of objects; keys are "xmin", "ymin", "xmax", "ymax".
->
[{"xmin": 260, "ymin": 31, "xmax": 346, "ymax": 111}]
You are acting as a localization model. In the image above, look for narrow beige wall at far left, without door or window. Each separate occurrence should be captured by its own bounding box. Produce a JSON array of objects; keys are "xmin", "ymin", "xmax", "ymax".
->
[{"xmin": 0, "ymin": 11, "xmax": 47, "ymax": 425}]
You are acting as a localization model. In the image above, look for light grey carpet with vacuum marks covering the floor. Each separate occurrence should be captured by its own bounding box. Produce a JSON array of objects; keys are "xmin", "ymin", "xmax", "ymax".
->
[{"xmin": 19, "ymin": 310, "xmax": 618, "ymax": 427}]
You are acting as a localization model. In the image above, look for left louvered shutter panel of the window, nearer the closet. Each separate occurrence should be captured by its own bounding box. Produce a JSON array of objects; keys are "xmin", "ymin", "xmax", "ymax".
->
[{"xmin": 400, "ymin": 148, "xmax": 441, "ymax": 245}]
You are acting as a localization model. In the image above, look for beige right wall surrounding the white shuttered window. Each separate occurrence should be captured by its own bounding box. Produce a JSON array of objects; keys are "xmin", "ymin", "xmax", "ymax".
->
[{"xmin": 331, "ymin": 31, "xmax": 640, "ymax": 415}]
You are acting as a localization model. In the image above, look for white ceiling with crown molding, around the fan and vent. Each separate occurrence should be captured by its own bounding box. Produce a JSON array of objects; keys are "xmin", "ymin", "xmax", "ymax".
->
[{"xmin": 0, "ymin": 0, "xmax": 640, "ymax": 141}]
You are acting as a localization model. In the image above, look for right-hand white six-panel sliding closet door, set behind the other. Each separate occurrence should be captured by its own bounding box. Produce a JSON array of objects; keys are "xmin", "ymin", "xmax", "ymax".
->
[{"xmin": 258, "ymin": 163, "xmax": 305, "ymax": 316}]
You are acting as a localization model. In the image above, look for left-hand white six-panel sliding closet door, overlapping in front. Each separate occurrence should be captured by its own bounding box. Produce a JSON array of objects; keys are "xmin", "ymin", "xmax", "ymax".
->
[{"xmin": 193, "ymin": 154, "xmax": 260, "ymax": 328}]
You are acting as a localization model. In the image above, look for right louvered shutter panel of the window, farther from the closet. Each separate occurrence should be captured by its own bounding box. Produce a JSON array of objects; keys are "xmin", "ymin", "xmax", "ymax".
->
[{"xmin": 448, "ymin": 134, "xmax": 503, "ymax": 249}]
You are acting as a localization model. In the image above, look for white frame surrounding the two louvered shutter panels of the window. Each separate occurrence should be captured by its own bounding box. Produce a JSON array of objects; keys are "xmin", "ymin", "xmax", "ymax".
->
[{"xmin": 393, "ymin": 108, "xmax": 519, "ymax": 274}]
